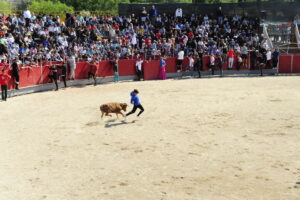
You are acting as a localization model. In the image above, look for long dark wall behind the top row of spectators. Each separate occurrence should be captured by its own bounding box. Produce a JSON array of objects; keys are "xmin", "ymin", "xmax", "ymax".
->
[{"xmin": 119, "ymin": 2, "xmax": 300, "ymax": 21}]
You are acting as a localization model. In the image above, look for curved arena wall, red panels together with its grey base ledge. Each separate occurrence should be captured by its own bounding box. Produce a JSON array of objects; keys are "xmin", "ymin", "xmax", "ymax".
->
[{"xmin": 0, "ymin": 54, "xmax": 300, "ymax": 96}]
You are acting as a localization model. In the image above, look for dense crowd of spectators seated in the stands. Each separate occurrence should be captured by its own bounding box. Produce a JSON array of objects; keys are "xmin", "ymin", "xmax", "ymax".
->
[{"xmin": 0, "ymin": 6, "xmax": 278, "ymax": 69}]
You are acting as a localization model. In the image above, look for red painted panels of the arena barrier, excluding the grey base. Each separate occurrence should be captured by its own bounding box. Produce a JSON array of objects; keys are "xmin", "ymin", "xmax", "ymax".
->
[{"xmin": 0, "ymin": 54, "xmax": 300, "ymax": 89}]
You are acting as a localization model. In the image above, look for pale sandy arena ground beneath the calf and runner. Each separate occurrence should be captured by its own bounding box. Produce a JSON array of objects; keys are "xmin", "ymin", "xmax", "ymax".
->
[{"xmin": 0, "ymin": 77, "xmax": 300, "ymax": 200}]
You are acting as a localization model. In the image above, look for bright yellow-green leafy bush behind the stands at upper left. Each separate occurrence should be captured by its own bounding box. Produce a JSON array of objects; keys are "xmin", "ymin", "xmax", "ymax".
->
[{"xmin": 28, "ymin": 0, "xmax": 73, "ymax": 16}]
